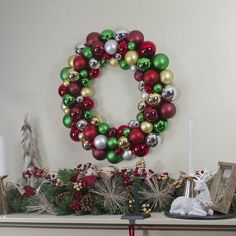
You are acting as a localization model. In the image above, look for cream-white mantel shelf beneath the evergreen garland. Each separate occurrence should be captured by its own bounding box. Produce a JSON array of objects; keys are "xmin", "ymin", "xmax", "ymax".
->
[{"xmin": 0, "ymin": 213, "xmax": 236, "ymax": 231}]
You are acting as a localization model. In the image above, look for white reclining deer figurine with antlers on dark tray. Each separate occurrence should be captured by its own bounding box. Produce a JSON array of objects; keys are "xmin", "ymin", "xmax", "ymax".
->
[{"xmin": 170, "ymin": 169, "xmax": 214, "ymax": 216}]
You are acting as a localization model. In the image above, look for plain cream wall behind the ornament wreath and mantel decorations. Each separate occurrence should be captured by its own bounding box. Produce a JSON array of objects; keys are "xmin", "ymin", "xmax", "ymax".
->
[{"xmin": 0, "ymin": 0, "xmax": 236, "ymax": 183}]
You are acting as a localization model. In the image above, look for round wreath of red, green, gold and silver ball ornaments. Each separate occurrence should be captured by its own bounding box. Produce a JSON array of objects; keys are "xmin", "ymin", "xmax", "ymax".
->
[{"xmin": 58, "ymin": 29, "xmax": 176, "ymax": 164}]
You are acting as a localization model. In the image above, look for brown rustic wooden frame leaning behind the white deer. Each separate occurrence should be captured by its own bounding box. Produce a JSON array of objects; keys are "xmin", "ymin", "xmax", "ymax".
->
[{"xmin": 210, "ymin": 162, "xmax": 236, "ymax": 214}]
